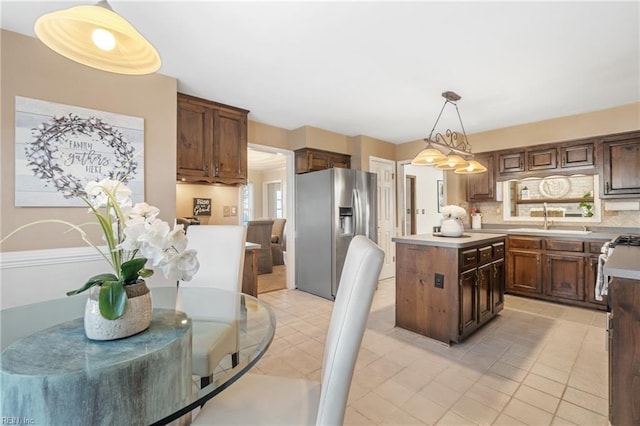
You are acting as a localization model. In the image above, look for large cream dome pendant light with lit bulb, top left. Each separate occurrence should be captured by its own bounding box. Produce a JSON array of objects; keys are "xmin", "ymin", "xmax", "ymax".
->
[{"xmin": 34, "ymin": 0, "xmax": 161, "ymax": 75}]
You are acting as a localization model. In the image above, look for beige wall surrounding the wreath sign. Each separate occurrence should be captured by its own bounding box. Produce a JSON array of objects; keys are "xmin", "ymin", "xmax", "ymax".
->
[{"xmin": 0, "ymin": 30, "xmax": 177, "ymax": 251}]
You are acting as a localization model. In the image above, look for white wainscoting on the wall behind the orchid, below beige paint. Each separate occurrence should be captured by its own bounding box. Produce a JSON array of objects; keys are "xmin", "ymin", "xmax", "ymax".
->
[{"xmin": 0, "ymin": 247, "xmax": 175, "ymax": 315}]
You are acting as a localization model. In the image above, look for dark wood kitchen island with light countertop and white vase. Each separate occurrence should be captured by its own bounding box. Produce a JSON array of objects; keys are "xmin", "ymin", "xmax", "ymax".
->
[{"xmin": 393, "ymin": 232, "xmax": 507, "ymax": 345}]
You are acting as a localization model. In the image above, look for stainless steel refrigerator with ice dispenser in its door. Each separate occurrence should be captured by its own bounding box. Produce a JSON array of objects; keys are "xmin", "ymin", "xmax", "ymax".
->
[{"xmin": 295, "ymin": 168, "xmax": 378, "ymax": 300}]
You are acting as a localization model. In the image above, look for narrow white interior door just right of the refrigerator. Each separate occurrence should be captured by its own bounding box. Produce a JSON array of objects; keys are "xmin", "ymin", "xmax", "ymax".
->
[{"xmin": 369, "ymin": 157, "xmax": 396, "ymax": 280}]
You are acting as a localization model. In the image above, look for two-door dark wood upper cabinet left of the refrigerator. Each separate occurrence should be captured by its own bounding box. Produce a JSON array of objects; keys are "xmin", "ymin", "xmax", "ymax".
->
[{"xmin": 177, "ymin": 93, "xmax": 249, "ymax": 185}]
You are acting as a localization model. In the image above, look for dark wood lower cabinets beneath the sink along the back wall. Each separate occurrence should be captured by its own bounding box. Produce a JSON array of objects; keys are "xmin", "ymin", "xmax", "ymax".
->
[{"xmin": 506, "ymin": 236, "xmax": 606, "ymax": 310}]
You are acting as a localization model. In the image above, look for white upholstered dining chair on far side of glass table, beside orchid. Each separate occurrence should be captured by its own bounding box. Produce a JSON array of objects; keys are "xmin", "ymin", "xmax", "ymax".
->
[{"xmin": 179, "ymin": 225, "xmax": 246, "ymax": 387}]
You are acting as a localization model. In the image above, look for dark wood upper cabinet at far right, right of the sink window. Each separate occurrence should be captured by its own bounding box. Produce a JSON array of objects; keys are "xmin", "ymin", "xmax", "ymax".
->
[{"xmin": 600, "ymin": 133, "xmax": 640, "ymax": 198}]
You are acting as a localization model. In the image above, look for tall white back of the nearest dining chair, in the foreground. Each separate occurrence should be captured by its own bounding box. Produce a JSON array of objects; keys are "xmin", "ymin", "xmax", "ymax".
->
[{"xmin": 316, "ymin": 235, "xmax": 384, "ymax": 425}]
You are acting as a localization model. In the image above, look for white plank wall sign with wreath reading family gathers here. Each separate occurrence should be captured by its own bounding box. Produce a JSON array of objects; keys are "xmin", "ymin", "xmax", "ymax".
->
[{"xmin": 15, "ymin": 96, "xmax": 144, "ymax": 207}]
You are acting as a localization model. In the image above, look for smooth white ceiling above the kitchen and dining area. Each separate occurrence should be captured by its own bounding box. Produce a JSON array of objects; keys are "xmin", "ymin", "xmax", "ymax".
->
[{"xmin": 1, "ymin": 0, "xmax": 640, "ymax": 148}]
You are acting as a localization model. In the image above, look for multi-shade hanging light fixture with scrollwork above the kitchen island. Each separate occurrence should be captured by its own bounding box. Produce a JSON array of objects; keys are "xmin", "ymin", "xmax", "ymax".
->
[{"xmin": 411, "ymin": 91, "xmax": 487, "ymax": 174}]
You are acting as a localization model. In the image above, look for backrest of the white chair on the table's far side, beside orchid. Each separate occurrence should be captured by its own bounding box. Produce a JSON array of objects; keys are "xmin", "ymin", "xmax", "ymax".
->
[{"xmin": 180, "ymin": 225, "xmax": 246, "ymax": 292}]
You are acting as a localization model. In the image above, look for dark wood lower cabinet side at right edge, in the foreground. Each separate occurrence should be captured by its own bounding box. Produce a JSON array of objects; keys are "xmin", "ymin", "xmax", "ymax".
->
[{"xmin": 609, "ymin": 278, "xmax": 640, "ymax": 426}]
